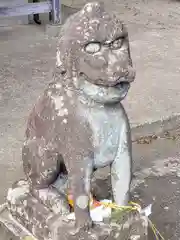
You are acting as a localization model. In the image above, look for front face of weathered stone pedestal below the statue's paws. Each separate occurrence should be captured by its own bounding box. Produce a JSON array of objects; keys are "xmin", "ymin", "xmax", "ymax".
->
[{"xmin": 47, "ymin": 214, "xmax": 148, "ymax": 240}]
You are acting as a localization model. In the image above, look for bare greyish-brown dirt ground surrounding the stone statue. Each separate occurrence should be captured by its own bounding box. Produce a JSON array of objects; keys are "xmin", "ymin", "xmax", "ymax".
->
[{"xmin": 0, "ymin": 0, "xmax": 180, "ymax": 240}]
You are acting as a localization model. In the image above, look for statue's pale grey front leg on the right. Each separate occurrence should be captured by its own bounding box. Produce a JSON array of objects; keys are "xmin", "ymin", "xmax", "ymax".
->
[{"xmin": 111, "ymin": 120, "xmax": 132, "ymax": 206}]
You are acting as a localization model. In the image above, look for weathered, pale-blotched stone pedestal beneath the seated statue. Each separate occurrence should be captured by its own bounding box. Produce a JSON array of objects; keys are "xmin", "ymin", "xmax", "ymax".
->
[{"xmin": 1, "ymin": 180, "xmax": 148, "ymax": 240}]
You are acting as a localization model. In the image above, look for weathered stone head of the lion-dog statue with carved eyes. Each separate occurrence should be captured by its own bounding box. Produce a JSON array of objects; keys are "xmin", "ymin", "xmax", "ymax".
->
[{"xmin": 56, "ymin": 2, "xmax": 135, "ymax": 102}]
